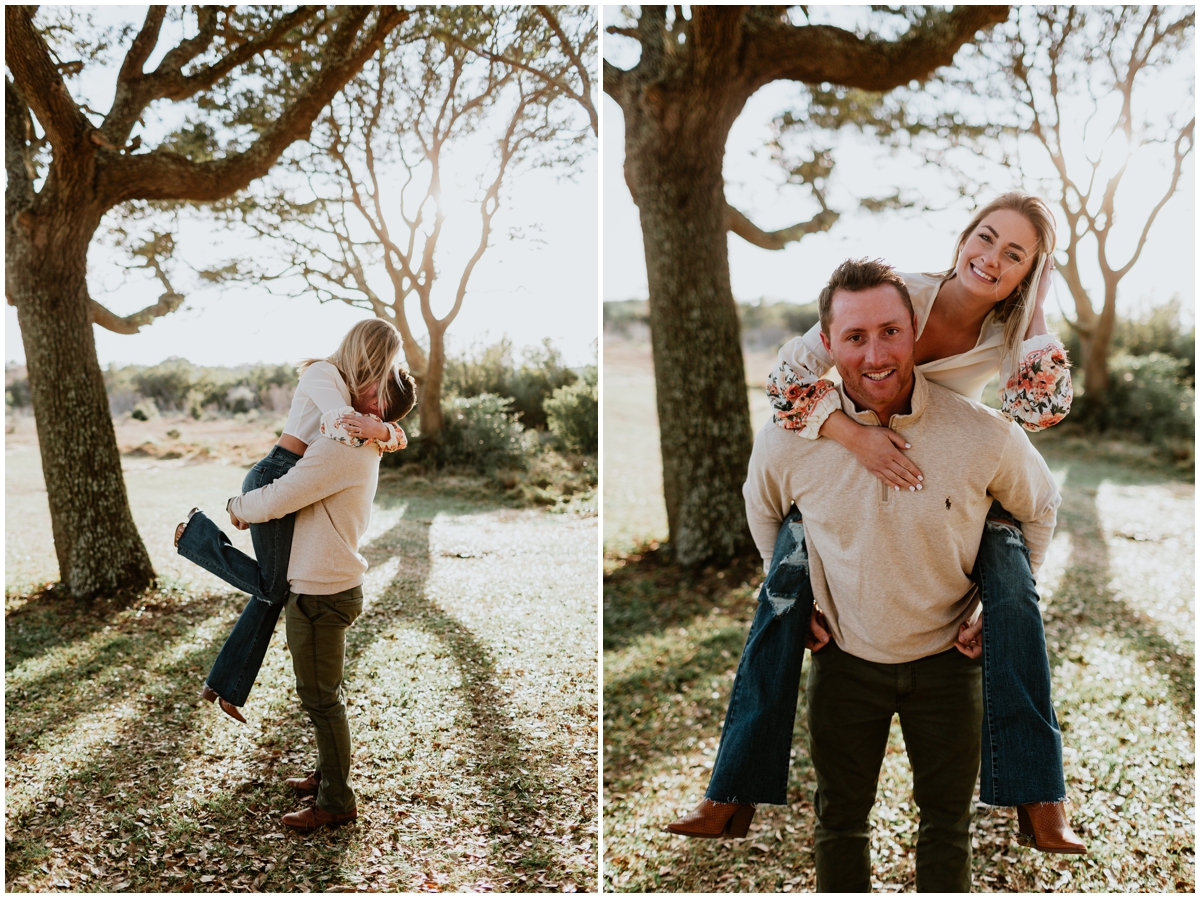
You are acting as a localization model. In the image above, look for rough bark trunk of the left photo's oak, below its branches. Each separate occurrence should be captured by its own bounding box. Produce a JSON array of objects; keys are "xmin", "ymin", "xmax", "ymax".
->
[{"xmin": 6, "ymin": 208, "xmax": 155, "ymax": 599}]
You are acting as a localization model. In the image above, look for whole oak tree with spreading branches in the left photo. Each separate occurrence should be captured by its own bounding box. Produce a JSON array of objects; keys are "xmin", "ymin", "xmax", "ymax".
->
[{"xmin": 5, "ymin": 6, "xmax": 410, "ymax": 598}]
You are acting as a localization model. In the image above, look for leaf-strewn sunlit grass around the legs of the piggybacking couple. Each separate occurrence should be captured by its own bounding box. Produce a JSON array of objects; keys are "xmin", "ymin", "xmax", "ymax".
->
[{"xmin": 604, "ymin": 336, "xmax": 1195, "ymax": 892}]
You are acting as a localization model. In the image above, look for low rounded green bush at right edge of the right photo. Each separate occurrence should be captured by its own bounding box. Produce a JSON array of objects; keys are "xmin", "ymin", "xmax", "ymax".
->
[{"xmin": 1086, "ymin": 352, "xmax": 1195, "ymax": 442}]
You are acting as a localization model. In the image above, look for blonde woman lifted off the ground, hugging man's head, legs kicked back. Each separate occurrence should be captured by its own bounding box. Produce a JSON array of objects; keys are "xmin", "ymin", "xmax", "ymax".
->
[{"xmin": 175, "ymin": 318, "xmax": 414, "ymax": 723}]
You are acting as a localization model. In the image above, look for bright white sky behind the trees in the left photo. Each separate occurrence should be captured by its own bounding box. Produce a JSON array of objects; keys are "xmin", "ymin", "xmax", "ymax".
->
[{"xmin": 5, "ymin": 7, "xmax": 599, "ymax": 365}]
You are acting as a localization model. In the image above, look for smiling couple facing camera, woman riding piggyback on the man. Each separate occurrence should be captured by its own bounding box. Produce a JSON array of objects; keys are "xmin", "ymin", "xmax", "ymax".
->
[{"xmin": 667, "ymin": 193, "xmax": 1086, "ymax": 892}]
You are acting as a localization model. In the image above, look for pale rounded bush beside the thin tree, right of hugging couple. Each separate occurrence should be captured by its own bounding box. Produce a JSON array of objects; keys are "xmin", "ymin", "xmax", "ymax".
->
[{"xmin": 438, "ymin": 393, "xmax": 530, "ymax": 473}]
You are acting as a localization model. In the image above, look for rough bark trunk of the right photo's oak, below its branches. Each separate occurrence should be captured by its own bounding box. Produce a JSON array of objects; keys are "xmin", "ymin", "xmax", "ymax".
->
[{"xmin": 625, "ymin": 86, "xmax": 752, "ymax": 564}]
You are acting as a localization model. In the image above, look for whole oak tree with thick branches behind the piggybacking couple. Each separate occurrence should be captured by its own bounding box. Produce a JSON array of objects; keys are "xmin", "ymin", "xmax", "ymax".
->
[{"xmin": 604, "ymin": 6, "xmax": 1008, "ymax": 564}]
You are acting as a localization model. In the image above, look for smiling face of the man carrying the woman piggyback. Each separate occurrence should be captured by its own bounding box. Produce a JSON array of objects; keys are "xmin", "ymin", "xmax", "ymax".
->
[{"xmin": 821, "ymin": 283, "xmax": 917, "ymax": 423}]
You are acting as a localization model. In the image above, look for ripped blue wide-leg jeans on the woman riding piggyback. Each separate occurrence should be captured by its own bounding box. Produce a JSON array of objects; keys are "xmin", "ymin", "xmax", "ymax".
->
[{"xmin": 706, "ymin": 503, "xmax": 1067, "ymax": 807}]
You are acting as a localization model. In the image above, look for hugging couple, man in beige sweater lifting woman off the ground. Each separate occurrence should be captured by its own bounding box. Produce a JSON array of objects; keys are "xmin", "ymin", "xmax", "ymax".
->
[{"xmin": 175, "ymin": 318, "xmax": 416, "ymax": 831}]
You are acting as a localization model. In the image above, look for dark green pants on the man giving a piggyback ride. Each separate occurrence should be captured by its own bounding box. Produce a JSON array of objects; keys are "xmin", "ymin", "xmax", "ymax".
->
[{"xmin": 808, "ymin": 642, "xmax": 983, "ymax": 892}]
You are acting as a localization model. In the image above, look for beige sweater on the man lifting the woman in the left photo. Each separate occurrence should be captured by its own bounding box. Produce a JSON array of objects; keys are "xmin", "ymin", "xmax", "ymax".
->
[{"xmin": 229, "ymin": 439, "xmax": 379, "ymax": 595}]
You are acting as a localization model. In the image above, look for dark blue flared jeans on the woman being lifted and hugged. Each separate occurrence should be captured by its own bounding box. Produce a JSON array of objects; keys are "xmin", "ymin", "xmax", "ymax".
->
[{"xmin": 179, "ymin": 445, "xmax": 301, "ymax": 707}]
